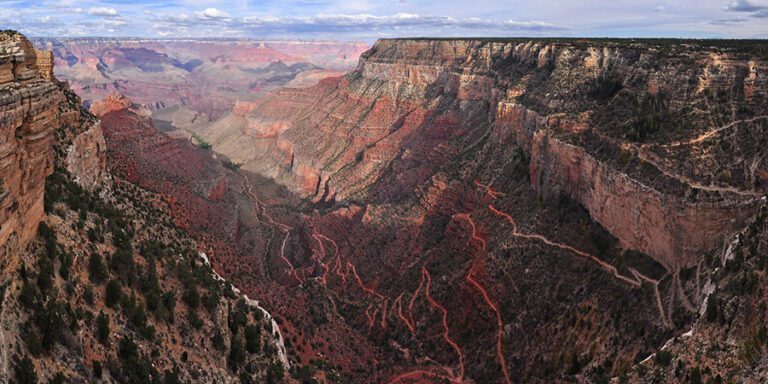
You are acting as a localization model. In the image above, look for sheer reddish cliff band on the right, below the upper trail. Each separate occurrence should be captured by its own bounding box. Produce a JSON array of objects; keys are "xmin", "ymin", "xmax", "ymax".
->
[{"xmin": 531, "ymin": 130, "xmax": 761, "ymax": 270}]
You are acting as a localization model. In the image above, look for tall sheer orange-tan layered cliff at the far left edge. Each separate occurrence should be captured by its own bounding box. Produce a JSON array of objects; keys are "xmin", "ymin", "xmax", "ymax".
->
[{"xmin": 0, "ymin": 33, "xmax": 58, "ymax": 270}]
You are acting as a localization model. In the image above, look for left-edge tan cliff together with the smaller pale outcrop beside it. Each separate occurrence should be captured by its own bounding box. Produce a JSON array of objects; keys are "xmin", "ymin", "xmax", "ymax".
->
[{"xmin": 0, "ymin": 33, "xmax": 105, "ymax": 270}]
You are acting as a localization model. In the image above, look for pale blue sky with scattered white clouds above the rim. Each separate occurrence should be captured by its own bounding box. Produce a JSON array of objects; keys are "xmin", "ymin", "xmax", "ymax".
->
[{"xmin": 0, "ymin": 0, "xmax": 768, "ymax": 42}]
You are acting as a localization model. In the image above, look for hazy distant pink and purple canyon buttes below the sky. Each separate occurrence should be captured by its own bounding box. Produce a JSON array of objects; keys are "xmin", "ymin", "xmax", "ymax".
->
[{"xmin": 32, "ymin": 38, "xmax": 369, "ymax": 148}]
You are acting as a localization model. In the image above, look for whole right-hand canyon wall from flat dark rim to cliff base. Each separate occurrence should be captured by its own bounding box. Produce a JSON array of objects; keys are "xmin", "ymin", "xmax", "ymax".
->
[{"xmin": 242, "ymin": 39, "xmax": 768, "ymax": 269}]
